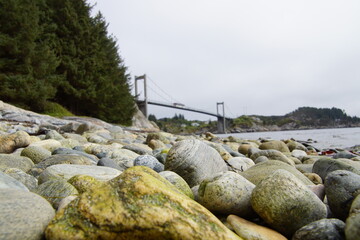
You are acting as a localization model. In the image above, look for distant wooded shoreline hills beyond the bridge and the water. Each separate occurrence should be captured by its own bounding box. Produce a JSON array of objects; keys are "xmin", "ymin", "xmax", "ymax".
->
[{"xmin": 149, "ymin": 107, "xmax": 360, "ymax": 134}]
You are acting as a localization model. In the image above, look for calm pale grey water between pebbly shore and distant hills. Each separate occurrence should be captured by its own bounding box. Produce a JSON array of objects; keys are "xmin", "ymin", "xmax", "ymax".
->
[{"xmin": 219, "ymin": 128, "xmax": 360, "ymax": 149}]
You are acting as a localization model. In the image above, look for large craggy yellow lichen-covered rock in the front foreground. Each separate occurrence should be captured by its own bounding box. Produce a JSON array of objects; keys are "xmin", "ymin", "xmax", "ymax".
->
[{"xmin": 46, "ymin": 166, "xmax": 241, "ymax": 240}]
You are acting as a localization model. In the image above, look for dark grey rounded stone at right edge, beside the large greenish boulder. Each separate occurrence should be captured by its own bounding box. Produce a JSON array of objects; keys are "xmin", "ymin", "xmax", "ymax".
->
[{"xmin": 324, "ymin": 170, "xmax": 360, "ymax": 221}]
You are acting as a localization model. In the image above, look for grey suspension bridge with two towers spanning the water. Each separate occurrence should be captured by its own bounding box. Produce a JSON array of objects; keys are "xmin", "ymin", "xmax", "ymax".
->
[{"xmin": 135, "ymin": 74, "xmax": 231, "ymax": 133}]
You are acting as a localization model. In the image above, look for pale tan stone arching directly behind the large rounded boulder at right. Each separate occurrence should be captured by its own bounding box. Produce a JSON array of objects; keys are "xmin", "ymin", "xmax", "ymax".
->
[{"xmin": 240, "ymin": 160, "xmax": 314, "ymax": 185}]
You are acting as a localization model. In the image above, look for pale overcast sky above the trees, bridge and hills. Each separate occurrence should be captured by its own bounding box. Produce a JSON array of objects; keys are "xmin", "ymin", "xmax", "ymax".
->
[{"xmin": 88, "ymin": 0, "xmax": 360, "ymax": 120}]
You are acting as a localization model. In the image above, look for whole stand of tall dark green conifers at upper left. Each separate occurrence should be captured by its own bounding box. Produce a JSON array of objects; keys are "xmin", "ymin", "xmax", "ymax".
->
[{"xmin": 0, "ymin": 0, "xmax": 134, "ymax": 124}]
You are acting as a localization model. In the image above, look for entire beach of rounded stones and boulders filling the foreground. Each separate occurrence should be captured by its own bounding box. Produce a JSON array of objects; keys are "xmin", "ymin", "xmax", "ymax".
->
[{"xmin": 0, "ymin": 101, "xmax": 360, "ymax": 240}]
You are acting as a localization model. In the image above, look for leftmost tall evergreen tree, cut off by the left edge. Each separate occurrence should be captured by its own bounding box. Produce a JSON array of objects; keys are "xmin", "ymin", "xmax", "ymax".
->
[{"xmin": 0, "ymin": 0, "xmax": 60, "ymax": 111}]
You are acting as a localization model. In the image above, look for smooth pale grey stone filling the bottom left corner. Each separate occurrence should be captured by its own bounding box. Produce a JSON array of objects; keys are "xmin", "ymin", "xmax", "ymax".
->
[{"xmin": 0, "ymin": 189, "xmax": 55, "ymax": 240}]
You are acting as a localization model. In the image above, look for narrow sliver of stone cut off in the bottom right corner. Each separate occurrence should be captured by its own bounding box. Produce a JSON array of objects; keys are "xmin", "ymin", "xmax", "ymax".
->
[{"xmin": 345, "ymin": 194, "xmax": 360, "ymax": 240}]
